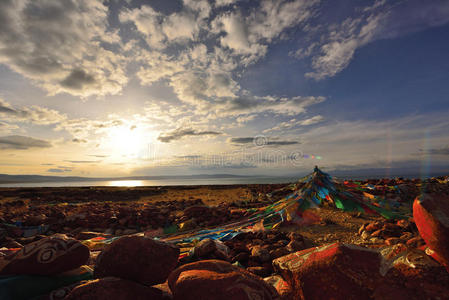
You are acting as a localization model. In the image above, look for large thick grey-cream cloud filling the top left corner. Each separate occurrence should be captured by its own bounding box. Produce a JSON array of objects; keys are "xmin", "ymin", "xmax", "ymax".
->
[{"xmin": 0, "ymin": 0, "xmax": 128, "ymax": 97}]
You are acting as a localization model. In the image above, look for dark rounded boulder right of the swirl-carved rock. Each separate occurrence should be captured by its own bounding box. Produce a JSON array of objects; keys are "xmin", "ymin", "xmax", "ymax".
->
[{"xmin": 94, "ymin": 236, "xmax": 179, "ymax": 286}]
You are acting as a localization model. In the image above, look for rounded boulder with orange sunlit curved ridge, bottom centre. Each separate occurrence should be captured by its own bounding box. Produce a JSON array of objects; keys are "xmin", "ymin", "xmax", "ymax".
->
[{"xmin": 168, "ymin": 260, "xmax": 279, "ymax": 300}]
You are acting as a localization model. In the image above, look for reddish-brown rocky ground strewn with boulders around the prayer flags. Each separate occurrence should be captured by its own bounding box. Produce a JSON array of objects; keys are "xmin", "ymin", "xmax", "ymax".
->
[{"xmin": 0, "ymin": 184, "xmax": 449, "ymax": 299}]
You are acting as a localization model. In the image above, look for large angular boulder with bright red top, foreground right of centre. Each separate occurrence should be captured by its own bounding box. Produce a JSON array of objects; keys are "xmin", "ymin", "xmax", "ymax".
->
[{"xmin": 273, "ymin": 243, "xmax": 381, "ymax": 299}]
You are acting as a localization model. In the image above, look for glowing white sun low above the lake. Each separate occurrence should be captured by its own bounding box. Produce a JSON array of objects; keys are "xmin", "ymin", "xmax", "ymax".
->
[{"xmin": 107, "ymin": 126, "xmax": 148, "ymax": 157}]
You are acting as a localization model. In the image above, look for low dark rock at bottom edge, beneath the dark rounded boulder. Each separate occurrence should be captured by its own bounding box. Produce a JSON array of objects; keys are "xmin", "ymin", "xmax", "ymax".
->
[{"xmin": 64, "ymin": 277, "xmax": 167, "ymax": 300}]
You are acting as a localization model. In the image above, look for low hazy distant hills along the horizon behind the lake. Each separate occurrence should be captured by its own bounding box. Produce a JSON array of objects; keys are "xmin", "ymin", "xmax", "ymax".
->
[{"xmin": 0, "ymin": 174, "xmax": 253, "ymax": 184}]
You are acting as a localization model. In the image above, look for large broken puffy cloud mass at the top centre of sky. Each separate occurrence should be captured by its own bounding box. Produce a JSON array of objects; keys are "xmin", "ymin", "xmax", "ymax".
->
[{"xmin": 123, "ymin": 0, "xmax": 324, "ymax": 116}]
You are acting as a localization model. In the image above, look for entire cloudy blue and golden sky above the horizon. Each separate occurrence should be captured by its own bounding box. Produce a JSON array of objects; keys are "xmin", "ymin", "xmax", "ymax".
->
[{"xmin": 0, "ymin": 0, "xmax": 449, "ymax": 177}]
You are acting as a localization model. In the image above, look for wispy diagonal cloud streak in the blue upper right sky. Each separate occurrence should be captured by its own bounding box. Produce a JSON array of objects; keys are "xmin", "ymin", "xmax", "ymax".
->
[{"xmin": 300, "ymin": 1, "xmax": 449, "ymax": 80}]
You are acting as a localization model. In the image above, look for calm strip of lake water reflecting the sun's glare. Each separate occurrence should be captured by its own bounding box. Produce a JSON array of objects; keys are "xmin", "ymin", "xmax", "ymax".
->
[{"xmin": 0, "ymin": 177, "xmax": 298, "ymax": 187}]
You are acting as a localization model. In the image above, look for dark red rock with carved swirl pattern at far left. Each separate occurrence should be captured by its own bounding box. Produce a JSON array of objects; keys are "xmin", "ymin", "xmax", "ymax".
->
[{"xmin": 0, "ymin": 234, "xmax": 90, "ymax": 275}]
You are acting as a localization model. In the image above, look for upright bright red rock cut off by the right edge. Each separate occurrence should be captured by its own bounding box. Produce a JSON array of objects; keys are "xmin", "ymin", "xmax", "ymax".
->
[{"xmin": 413, "ymin": 194, "xmax": 449, "ymax": 266}]
